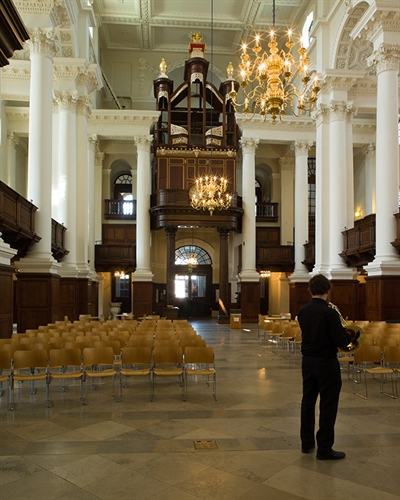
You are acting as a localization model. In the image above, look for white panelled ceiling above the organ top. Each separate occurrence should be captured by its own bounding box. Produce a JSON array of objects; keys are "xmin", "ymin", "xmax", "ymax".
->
[{"xmin": 93, "ymin": 0, "xmax": 309, "ymax": 55}]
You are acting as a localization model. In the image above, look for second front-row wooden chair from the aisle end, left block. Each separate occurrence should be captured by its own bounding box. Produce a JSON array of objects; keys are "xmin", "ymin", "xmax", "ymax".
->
[{"xmin": 152, "ymin": 346, "xmax": 185, "ymax": 401}]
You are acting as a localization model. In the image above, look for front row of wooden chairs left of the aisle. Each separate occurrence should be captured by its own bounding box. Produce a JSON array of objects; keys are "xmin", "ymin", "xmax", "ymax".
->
[{"xmin": 0, "ymin": 346, "xmax": 216, "ymax": 410}]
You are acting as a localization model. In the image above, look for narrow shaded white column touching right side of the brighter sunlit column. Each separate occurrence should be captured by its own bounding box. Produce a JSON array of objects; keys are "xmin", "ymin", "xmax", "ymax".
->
[{"xmin": 76, "ymin": 96, "xmax": 90, "ymax": 278}]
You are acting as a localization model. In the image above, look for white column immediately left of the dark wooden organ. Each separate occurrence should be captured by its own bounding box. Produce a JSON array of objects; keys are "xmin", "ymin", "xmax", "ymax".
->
[{"xmin": 133, "ymin": 135, "xmax": 153, "ymax": 281}]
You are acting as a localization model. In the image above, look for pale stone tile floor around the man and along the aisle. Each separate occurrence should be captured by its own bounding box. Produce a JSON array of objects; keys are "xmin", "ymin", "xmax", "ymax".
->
[{"xmin": 0, "ymin": 321, "xmax": 400, "ymax": 500}]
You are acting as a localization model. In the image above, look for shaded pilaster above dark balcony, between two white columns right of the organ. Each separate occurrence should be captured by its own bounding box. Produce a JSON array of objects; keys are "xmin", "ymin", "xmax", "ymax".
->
[{"xmin": 279, "ymin": 158, "xmax": 294, "ymax": 245}]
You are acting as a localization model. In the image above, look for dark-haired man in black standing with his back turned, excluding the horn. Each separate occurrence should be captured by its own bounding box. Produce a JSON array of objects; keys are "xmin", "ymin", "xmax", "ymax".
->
[{"xmin": 298, "ymin": 274, "xmax": 353, "ymax": 460}]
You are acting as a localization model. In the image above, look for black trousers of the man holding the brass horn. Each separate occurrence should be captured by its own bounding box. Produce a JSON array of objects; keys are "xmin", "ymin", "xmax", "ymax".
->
[{"xmin": 300, "ymin": 356, "xmax": 342, "ymax": 453}]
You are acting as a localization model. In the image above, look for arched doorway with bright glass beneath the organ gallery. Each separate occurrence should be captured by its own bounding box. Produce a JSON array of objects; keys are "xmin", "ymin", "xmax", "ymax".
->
[{"xmin": 175, "ymin": 245, "xmax": 212, "ymax": 318}]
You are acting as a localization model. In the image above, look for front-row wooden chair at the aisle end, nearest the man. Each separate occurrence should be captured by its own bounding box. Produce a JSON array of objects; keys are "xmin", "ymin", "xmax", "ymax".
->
[{"xmin": 185, "ymin": 347, "xmax": 217, "ymax": 401}]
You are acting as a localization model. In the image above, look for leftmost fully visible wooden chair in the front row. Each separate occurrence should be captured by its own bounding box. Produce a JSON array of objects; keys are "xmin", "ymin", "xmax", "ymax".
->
[{"xmin": 10, "ymin": 349, "xmax": 51, "ymax": 411}]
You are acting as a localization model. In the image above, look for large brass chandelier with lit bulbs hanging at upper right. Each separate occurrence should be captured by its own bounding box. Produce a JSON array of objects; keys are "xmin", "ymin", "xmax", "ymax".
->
[{"xmin": 227, "ymin": 0, "xmax": 320, "ymax": 123}]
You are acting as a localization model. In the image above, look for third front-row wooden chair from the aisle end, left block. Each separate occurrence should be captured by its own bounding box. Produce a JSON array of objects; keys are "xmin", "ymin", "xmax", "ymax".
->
[{"xmin": 119, "ymin": 347, "xmax": 153, "ymax": 401}]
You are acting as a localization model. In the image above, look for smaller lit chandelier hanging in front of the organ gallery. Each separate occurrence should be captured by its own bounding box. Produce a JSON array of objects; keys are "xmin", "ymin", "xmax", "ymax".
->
[{"xmin": 189, "ymin": 175, "xmax": 232, "ymax": 215}]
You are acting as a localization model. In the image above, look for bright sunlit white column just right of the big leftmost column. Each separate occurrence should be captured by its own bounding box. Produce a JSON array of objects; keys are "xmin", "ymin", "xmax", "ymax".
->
[{"xmin": 54, "ymin": 91, "xmax": 78, "ymax": 277}]
